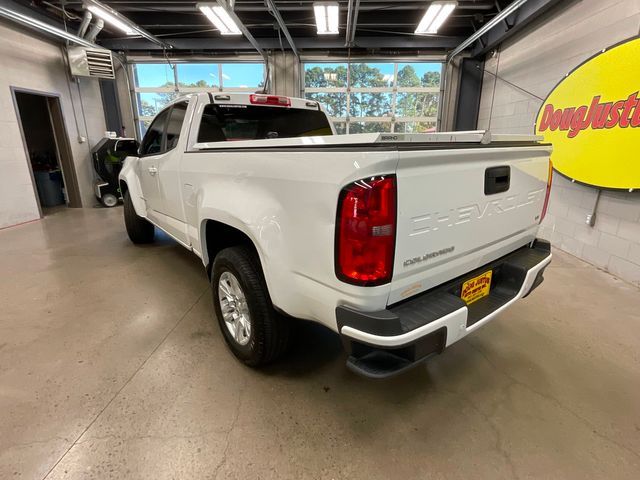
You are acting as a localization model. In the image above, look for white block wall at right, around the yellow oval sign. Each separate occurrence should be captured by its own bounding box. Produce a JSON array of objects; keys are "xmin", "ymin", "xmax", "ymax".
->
[{"xmin": 478, "ymin": 0, "xmax": 640, "ymax": 285}]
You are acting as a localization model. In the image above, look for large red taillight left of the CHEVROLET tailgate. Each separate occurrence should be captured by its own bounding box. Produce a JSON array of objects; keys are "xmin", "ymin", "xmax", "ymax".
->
[{"xmin": 336, "ymin": 175, "xmax": 396, "ymax": 286}]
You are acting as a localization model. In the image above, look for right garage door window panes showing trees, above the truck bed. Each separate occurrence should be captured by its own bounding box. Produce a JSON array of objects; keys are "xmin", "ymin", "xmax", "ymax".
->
[{"xmin": 303, "ymin": 62, "xmax": 442, "ymax": 134}]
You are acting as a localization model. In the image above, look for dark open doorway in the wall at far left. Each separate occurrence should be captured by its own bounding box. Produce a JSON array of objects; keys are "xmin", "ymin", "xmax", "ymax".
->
[{"xmin": 12, "ymin": 89, "xmax": 82, "ymax": 216}]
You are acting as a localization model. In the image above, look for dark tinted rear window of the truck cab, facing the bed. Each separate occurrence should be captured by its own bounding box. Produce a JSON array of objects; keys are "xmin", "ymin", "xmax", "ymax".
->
[{"xmin": 198, "ymin": 104, "xmax": 332, "ymax": 143}]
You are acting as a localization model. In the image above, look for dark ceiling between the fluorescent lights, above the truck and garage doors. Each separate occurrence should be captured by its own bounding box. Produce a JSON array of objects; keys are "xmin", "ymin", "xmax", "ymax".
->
[{"xmin": 18, "ymin": 0, "xmax": 510, "ymax": 55}]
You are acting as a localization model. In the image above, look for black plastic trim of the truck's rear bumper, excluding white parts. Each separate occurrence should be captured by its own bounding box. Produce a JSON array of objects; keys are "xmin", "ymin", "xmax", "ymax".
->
[{"xmin": 336, "ymin": 240, "xmax": 551, "ymax": 378}]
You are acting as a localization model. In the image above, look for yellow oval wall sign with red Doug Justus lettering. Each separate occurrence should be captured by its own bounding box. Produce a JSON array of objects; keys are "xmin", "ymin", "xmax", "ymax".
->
[{"xmin": 536, "ymin": 37, "xmax": 640, "ymax": 190}]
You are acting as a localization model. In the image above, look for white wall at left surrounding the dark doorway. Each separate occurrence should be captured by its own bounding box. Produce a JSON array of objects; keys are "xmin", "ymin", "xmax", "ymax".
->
[{"xmin": 0, "ymin": 21, "xmax": 106, "ymax": 228}]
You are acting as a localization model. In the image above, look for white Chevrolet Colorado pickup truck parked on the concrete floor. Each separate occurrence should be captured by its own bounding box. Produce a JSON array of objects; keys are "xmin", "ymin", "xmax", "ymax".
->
[{"xmin": 120, "ymin": 93, "xmax": 551, "ymax": 377}]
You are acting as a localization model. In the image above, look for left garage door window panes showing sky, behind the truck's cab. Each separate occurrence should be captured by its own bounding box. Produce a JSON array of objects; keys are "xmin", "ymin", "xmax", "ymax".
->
[{"xmin": 133, "ymin": 62, "xmax": 264, "ymax": 137}]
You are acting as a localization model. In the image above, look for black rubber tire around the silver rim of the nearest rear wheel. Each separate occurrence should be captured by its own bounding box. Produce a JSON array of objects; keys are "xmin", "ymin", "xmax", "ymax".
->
[{"xmin": 211, "ymin": 246, "xmax": 291, "ymax": 367}]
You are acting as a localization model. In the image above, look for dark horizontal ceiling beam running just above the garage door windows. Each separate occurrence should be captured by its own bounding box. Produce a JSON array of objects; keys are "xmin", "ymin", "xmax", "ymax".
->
[{"xmin": 100, "ymin": 35, "xmax": 464, "ymax": 52}]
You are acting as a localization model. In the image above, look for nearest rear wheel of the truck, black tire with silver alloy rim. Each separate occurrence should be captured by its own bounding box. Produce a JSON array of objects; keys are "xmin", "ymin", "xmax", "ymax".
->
[{"xmin": 211, "ymin": 247, "xmax": 290, "ymax": 367}]
